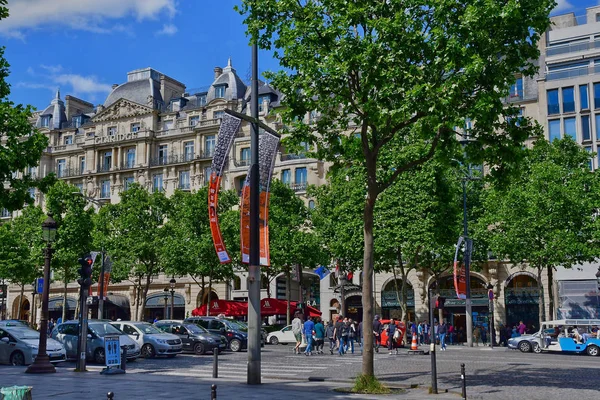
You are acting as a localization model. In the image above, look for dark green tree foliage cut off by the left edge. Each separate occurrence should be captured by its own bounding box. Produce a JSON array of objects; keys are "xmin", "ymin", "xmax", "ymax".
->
[{"xmin": 0, "ymin": 0, "xmax": 54, "ymax": 211}]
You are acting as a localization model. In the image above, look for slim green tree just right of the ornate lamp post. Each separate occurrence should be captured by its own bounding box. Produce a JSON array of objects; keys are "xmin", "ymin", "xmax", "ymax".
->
[{"xmin": 46, "ymin": 181, "xmax": 94, "ymax": 321}]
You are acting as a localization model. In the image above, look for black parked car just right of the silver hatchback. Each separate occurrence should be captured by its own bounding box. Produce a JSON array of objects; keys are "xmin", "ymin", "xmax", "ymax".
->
[{"xmin": 154, "ymin": 320, "xmax": 227, "ymax": 354}]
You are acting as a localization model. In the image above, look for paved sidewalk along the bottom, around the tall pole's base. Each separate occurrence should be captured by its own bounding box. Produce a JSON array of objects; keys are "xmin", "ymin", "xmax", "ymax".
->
[{"xmin": 0, "ymin": 367, "xmax": 460, "ymax": 400}]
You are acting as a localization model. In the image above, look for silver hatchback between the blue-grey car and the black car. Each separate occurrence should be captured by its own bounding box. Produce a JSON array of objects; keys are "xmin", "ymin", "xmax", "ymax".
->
[{"xmin": 111, "ymin": 321, "xmax": 182, "ymax": 358}]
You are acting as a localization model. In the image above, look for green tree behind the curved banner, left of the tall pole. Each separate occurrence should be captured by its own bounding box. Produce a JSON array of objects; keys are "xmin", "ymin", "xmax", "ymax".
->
[{"xmin": 161, "ymin": 186, "xmax": 240, "ymax": 312}]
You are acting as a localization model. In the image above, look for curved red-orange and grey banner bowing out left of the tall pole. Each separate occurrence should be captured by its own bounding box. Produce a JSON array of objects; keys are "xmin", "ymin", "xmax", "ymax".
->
[{"xmin": 208, "ymin": 113, "xmax": 242, "ymax": 264}]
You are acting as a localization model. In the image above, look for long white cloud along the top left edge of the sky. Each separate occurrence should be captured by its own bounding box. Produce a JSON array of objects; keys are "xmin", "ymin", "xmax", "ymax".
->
[{"xmin": 0, "ymin": 0, "xmax": 176, "ymax": 39}]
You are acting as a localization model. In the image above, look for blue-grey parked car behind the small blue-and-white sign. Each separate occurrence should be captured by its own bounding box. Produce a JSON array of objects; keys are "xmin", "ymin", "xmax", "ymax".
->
[{"xmin": 51, "ymin": 320, "xmax": 140, "ymax": 364}]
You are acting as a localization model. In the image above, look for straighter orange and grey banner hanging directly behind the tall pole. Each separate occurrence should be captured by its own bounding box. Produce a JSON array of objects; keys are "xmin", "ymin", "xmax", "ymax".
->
[{"xmin": 240, "ymin": 132, "xmax": 279, "ymax": 266}]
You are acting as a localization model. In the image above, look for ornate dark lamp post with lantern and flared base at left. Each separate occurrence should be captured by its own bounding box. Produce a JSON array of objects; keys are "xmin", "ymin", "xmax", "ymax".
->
[{"xmin": 25, "ymin": 213, "xmax": 56, "ymax": 374}]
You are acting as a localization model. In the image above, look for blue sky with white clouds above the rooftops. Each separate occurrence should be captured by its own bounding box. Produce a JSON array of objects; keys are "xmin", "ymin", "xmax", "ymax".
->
[{"xmin": 0, "ymin": 0, "xmax": 598, "ymax": 109}]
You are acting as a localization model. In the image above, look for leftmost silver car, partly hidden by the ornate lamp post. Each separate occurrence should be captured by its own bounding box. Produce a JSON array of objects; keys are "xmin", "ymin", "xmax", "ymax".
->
[{"xmin": 0, "ymin": 324, "xmax": 67, "ymax": 365}]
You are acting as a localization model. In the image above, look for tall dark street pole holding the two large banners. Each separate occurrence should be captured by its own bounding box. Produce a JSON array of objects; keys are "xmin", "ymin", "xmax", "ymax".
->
[{"xmin": 247, "ymin": 39, "xmax": 261, "ymax": 385}]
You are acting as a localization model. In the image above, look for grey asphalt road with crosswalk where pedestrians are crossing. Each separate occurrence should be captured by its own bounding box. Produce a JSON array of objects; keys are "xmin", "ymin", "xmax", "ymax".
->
[{"xmin": 49, "ymin": 345, "xmax": 600, "ymax": 400}]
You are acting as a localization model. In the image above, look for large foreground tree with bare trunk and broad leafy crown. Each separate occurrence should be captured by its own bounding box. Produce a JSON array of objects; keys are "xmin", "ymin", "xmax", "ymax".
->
[{"xmin": 239, "ymin": 0, "xmax": 555, "ymax": 376}]
